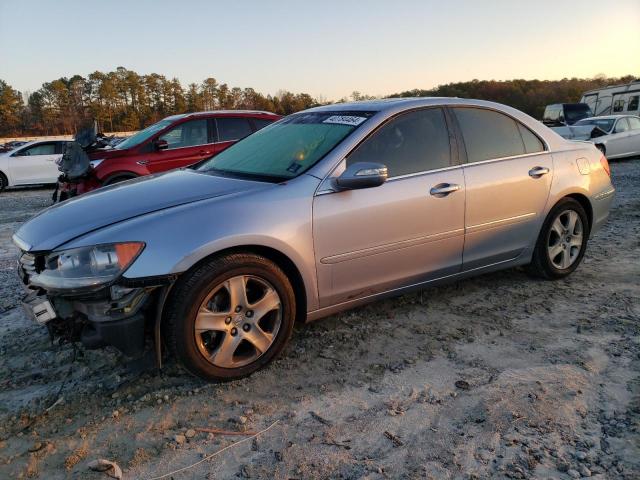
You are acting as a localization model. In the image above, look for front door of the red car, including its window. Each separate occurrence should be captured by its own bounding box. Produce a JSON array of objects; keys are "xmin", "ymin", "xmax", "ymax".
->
[{"xmin": 147, "ymin": 118, "xmax": 214, "ymax": 173}]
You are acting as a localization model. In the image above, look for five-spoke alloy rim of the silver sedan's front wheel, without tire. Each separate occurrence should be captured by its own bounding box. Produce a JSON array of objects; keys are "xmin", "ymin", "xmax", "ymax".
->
[{"xmin": 194, "ymin": 275, "xmax": 282, "ymax": 368}]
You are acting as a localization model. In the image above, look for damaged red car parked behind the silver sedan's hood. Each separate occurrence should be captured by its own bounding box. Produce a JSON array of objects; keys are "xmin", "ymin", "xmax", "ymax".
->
[{"xmin": 59, "ymin": 110, "xmax": 281, "ymax": 199}]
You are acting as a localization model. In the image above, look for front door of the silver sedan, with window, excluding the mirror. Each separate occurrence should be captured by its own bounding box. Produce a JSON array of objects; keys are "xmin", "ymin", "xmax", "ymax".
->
[{"xmin": 313, "ymin": 108, "xmax": 465, "ymax": 307}]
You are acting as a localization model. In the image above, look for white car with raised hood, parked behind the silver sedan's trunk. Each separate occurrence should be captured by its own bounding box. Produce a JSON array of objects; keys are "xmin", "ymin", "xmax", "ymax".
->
[{"xmin": 572, "ymin": 115, "xmax": 640, "ymax": 160}]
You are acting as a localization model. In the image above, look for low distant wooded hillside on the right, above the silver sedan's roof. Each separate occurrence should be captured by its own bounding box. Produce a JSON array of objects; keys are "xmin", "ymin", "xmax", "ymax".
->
[{"xmin": 389, "ymin": 75, "xmax": 639, "ymax": 119}]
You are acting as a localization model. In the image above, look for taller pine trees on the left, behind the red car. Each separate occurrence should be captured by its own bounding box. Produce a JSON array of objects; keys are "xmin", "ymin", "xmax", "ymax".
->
[{"xmin": 0, "ymin": 67, "xmax": 317, "ymax": 136}]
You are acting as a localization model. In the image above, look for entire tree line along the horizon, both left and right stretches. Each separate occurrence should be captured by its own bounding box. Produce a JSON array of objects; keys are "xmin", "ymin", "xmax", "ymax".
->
[{"xmin": 0, "ymin": 67, "xmax": 635, "ymax": 136}]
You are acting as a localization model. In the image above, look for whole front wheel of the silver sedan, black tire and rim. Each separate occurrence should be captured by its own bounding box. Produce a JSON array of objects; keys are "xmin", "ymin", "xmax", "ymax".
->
[{"xmin": 165, "ymin": 253, "xmax": 296, "ymax": 381}]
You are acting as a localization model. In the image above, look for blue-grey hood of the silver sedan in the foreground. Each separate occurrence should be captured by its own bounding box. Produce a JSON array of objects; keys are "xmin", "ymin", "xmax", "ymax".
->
[{"xmin": 14, "ymin": 170, "xmax": 274, "ymax": 251}]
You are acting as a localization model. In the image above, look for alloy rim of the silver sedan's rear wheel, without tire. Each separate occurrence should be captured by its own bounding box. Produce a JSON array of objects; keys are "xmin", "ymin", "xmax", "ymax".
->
[{"xmin": 547, "ymin": 210, "xmax": 584, "ymax": 270}]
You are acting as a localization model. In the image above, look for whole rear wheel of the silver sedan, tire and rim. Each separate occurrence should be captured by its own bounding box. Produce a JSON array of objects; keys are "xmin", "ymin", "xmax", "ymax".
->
[{"xmin": 527, "ymin": 197, "xmax": 590, "ymax": 280}]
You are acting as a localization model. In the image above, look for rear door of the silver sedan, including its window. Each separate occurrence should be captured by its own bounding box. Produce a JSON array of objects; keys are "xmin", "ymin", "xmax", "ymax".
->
[{"xmin": 453, "ymin": 107, "xmax": 553, "ymax": 271}]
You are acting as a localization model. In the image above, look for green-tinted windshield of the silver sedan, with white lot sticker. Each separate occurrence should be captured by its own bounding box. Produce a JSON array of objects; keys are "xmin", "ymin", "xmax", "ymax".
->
[{"xmin": 196, "ymin": 112, "xmax": 373, "ymax": 182}]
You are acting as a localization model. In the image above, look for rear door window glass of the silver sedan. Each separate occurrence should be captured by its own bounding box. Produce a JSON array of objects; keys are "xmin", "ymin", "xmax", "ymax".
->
[{"xmin": 454, "ymin": 108, "xmax": 525, "ymax": 162}]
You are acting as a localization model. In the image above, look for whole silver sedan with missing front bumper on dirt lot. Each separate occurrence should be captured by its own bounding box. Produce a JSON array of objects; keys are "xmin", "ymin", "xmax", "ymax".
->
[{"xmin": 14, "ymin": 98, "xmax": 614, "ymax": 379}]
